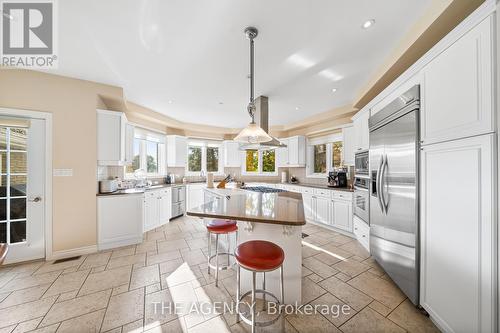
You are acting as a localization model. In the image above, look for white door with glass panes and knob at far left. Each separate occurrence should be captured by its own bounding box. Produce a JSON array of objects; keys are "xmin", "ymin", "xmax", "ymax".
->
[{"xmin": 0, "ymin": 119, "xmax": 45, "ymax": 263}]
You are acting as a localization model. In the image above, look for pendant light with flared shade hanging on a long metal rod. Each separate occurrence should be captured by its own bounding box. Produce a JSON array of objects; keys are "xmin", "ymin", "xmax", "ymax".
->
[{"xmin": 234, "ymin": 27, "xmax": 273, "ymax": 143}]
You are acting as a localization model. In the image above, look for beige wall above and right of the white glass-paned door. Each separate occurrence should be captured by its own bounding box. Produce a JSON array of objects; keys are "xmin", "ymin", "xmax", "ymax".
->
[{"xmin": 0, "ymin": 70, "xmax": 126, "ymax": 251}]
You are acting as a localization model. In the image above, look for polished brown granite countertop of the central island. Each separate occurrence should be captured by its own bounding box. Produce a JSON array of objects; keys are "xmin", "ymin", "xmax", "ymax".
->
[{"xmin": 186, "ymin": 188, "xmax": 306, "ymax": 226}]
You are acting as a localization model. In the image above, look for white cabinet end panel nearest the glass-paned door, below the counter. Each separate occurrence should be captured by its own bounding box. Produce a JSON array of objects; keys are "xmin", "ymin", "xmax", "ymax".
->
[{"xmin": 97, "ymin": 193, "xmax": 144, "ymax": 250}]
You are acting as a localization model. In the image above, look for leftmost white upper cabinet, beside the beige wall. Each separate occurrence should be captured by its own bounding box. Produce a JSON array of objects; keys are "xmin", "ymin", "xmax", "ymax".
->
[{"xmin": 97, "ymin": 110, "xmax": 134, "ymax": 165}]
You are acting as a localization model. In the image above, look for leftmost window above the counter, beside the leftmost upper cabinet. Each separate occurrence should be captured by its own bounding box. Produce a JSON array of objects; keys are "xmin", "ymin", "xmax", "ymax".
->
[{"xmin": 125, "ymin": 128, "xmax": 166, "ymax": 178}]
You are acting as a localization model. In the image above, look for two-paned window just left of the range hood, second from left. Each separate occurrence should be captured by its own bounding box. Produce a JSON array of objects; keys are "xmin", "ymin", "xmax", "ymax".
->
[{"xmin": 186, "ymin": 141, "xmax": 223, "ymax": 175}]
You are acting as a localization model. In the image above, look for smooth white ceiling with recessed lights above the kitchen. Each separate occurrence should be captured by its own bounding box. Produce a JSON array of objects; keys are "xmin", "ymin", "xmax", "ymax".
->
[{"xmin": 52, "ymin": 0, "xmax": 432, "ymax": 127}]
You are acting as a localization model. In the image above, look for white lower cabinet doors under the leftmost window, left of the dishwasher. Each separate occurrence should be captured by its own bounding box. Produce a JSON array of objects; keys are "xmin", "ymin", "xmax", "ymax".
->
[{"xmin": 144, "ymin": 188, "xmax": 172, "ymax": 232}]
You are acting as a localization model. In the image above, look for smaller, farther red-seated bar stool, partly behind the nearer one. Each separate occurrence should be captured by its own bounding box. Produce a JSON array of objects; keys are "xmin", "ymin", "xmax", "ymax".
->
[{"xmin": 206, "ymin": 219, "xmax": 238, "ymax": 287}]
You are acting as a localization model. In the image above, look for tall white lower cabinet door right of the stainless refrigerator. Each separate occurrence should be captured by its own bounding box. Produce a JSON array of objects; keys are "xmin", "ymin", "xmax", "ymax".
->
[{"xmin": 420, "ymin": 135, "xmax": 495, "ymax": 332}]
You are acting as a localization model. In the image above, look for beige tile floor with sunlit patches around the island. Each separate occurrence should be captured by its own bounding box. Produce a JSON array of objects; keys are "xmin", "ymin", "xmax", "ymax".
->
[{"xmin": 0, "ymin": 217, "xmax": 438, "ymax": 333}]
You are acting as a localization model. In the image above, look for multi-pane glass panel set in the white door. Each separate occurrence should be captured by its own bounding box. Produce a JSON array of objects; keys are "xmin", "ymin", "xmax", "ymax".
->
[{"xmin": 0, "ymin": 127, "xmax": 28, "ymax": 244}]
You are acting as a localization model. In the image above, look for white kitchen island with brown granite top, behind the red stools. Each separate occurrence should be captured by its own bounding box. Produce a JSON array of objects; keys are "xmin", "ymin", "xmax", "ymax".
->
[{"xmin": 187, "ymin": 188, "xmax": 306, "ymax": 304}]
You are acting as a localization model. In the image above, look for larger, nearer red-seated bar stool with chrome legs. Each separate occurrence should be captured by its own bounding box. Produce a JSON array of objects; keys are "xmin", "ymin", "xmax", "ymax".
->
[{"xmin": 234, "ymin": 240, "xmax": 285, "ymax": 333}]
